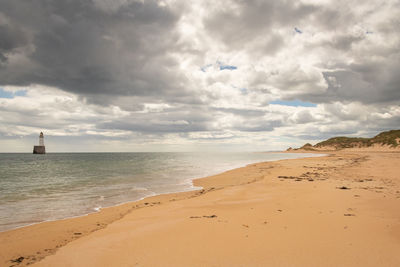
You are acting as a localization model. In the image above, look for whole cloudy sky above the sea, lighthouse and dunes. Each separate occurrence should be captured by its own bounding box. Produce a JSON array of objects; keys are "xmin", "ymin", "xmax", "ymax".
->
[{"xmin": 0, "ymin": 0, "xmax": 400, "ymax": 152}]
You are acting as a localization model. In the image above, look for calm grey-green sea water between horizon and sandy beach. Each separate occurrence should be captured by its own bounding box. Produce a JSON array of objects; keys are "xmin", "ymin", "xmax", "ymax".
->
[{"xmin": 0, "ymin": 153, "xmax": 318, "ymax": 231}]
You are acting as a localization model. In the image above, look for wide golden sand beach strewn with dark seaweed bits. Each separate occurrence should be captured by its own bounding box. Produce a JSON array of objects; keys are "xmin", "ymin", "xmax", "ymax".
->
[{"xmin": 0, "ymin": 152, "xmax": 400, "ymax": 266}]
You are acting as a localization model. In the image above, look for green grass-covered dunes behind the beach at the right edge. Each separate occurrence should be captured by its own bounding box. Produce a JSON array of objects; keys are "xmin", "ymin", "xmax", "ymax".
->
[{"xmin": 314, "ymin": 130, "xmax": 400, "ymax": 149}]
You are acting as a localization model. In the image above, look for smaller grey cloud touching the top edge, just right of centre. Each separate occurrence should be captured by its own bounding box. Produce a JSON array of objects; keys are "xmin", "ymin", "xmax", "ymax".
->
[{"xmin": 204, "ymin": 0, "xmax": 316, "ymax": 54}]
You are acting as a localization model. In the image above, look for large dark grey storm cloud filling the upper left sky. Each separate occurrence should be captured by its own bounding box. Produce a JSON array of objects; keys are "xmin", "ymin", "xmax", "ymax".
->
[{"xmin": 0, "ymin": 0, "xmax": 184, "ymax": 100}]
